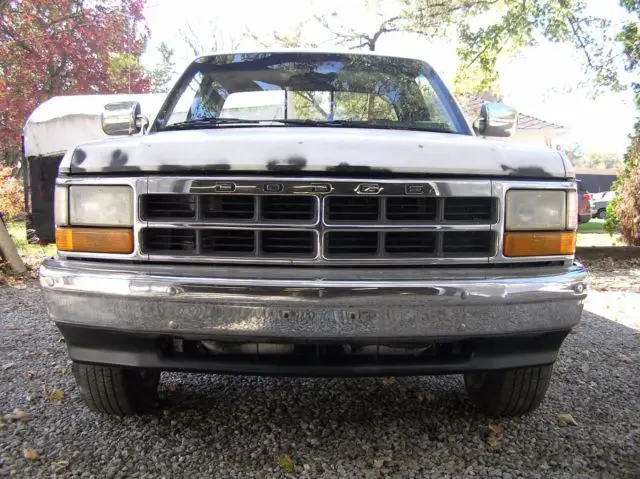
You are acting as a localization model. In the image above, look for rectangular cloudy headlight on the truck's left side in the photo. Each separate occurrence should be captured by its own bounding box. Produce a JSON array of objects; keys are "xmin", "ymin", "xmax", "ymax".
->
[{"xmin": 69, "ymin": 185, "xmax": 133, "ymax": 226}]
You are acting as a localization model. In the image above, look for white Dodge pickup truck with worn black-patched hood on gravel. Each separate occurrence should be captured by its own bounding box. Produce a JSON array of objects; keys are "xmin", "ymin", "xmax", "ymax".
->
[{"xmin": 40, "ymin": 51, "xmax": 587, "ymax": 415}]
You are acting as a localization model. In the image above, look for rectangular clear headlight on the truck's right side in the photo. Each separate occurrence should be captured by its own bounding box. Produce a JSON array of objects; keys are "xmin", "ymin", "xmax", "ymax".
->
[{"xmin": 505, "ymin": 190, "xmax": 567, "ymax": 231}]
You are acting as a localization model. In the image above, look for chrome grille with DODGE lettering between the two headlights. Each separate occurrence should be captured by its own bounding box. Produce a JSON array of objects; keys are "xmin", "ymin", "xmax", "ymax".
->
[{"xmin": 138, "ymin": 178, "xmax": 499, "ymax": 265}]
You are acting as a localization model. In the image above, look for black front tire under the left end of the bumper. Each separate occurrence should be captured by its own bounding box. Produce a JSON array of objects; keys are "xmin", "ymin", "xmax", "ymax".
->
[{"xmin": 73, "ymin": 363, "xmax": 160, "ymax": 416}]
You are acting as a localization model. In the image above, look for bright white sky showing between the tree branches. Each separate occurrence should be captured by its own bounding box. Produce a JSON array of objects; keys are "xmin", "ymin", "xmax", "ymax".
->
[{"xmin": 143, "ymin": 0, "xmax": 637, "ymax": 153}]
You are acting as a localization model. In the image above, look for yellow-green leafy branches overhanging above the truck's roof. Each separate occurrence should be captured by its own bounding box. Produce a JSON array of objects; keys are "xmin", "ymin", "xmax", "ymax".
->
[{"xmin": 258, "ymin": 0, "xmax": 620, "ymax": 93}]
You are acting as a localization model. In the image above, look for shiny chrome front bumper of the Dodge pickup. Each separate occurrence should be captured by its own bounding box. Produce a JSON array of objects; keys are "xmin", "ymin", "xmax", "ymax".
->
[{"xmin": 40, "ymin": 260, "xmax": 587, "ymax": 342}]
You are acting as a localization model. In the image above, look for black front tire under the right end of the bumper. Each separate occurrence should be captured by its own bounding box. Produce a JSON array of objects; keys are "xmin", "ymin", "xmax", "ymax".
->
[{"xmin": 464, "ymin": 364, "xmax": 553, "ymax": 416}]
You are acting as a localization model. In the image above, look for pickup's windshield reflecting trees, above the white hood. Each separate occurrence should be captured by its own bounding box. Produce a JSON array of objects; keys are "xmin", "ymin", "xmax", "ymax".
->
[{"xmin": 154, "ymin": 53, "xmax": 467, "ymax": 133}]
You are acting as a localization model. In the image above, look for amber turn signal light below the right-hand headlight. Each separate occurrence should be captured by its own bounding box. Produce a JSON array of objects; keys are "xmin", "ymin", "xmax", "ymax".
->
[{"xmin": 503, "ymin": 231, "xmax": 576, "ymax": 256}]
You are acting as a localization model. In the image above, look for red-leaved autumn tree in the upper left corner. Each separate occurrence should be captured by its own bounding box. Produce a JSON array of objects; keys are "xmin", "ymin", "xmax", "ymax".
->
[{"xmin": 0, "ymin": 0, "xmax": 150, "ymax": 163}]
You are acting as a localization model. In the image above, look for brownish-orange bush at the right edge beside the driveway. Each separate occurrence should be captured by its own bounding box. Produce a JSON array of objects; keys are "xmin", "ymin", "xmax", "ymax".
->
[{"xmin": 605, "ymin": 135, "xmax": 640, "ymax": 246}]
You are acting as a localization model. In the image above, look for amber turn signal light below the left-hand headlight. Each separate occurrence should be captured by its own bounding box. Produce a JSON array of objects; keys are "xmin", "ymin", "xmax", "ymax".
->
[{"xmin": 56, "ymin": 228, "xmax": 133, "ymax": 254}]
